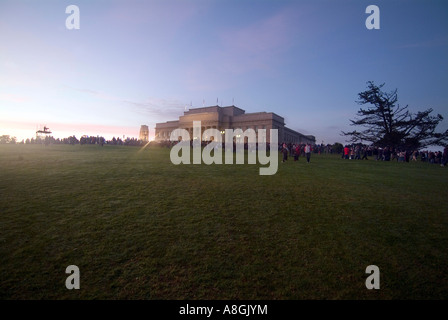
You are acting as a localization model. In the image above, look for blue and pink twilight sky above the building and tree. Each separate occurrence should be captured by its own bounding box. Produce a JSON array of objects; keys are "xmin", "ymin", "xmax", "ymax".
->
[{"xmin": 0, "ymin": 0, "xmax": 448, "ymax": 144}]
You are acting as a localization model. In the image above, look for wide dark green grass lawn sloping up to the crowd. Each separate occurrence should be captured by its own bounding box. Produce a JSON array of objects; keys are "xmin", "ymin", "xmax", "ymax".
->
[{"xmin": 0, "ymin": 145, "xmax": 448, "ymax": 300}]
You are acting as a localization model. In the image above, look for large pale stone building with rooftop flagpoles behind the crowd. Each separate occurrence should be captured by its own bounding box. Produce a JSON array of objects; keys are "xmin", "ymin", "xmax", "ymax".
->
[{"xmin": 155, "ymin": 106, "xmax": 316, "ymax": 144}]
